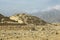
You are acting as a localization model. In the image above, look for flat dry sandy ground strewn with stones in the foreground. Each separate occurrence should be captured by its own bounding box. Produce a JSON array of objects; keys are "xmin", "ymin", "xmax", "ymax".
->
[{"xmin": 0, "ymin": 24, "xmax": 60, "ymax": 40}]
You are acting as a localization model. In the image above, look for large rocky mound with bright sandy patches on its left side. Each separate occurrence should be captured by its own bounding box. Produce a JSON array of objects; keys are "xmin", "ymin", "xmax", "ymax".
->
[{"xmin": 9, "ymin": 13, "xmax": 46, "ymax": 25}]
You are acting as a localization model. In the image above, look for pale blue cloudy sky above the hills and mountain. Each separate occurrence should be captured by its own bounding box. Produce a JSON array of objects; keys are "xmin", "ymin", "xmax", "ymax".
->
[{"xmin": 0, "ymin": 0, "xmax": 60, "ymax": 16}]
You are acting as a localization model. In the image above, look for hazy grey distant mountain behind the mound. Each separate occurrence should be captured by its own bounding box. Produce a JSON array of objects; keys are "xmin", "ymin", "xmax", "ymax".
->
[{"xmin": 32, "ymin": 9, "xmax": 60, "ymax": 23}]
